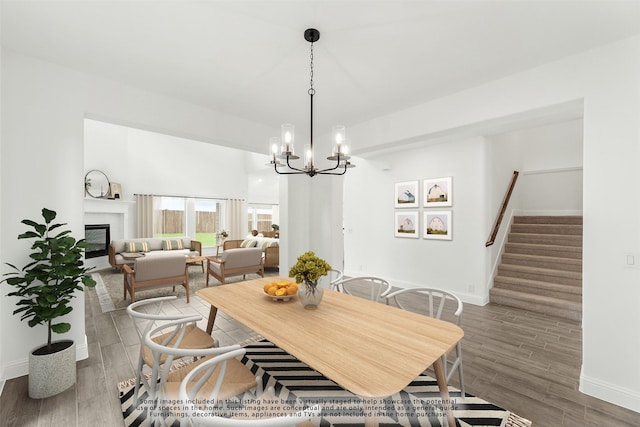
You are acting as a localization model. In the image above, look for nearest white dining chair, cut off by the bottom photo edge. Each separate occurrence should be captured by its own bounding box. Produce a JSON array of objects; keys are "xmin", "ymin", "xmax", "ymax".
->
[{"xmin": 178, "ymin": 348, "xmax": 321, "ymax": 427}]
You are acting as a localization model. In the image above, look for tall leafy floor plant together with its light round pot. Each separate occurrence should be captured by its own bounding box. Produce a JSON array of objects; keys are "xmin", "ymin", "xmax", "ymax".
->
[{"xmin": 0, "ymin": 208, "xmax": 96, "ymax": 399}]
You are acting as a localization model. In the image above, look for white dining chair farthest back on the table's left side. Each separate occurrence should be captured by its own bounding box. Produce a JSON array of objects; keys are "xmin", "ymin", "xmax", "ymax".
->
[{"xmin": 127, "ymin": 295, "xmax": 216, "ymax": 406}]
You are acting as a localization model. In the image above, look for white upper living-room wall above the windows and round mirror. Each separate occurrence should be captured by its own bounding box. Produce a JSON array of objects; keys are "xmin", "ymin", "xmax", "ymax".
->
[{"xmin": 84, "ymin": 120, "xmax": 251, "ymax": 200}]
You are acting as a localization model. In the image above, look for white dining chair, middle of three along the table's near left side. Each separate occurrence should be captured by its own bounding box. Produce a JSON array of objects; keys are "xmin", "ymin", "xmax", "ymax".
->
[{"xmin": 144, "ymin": 316, "xmax": 263, "ymax": 425}]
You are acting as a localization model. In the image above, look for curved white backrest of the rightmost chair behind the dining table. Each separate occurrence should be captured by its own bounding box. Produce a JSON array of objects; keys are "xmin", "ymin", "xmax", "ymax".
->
[{"xmin": 386, "ymin": 288, "xmax": 463, "ymax": 325}]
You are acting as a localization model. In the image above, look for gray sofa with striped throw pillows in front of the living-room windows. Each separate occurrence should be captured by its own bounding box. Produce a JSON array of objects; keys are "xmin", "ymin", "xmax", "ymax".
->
[{"xmin": 109, "ymin": 237, "xmax": 202, "ymax": 269}]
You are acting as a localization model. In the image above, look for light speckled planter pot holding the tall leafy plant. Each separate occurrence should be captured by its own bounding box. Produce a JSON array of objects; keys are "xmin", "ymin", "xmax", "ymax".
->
[{"xmin": 29, "ymin": 340, "xmax": 76, "ymax": 399}]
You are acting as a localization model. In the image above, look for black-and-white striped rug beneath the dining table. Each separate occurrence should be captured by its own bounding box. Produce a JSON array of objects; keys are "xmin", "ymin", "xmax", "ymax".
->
[{"xmin": 118, "ymin": 340, "xmax": 531, "ymax": 427}]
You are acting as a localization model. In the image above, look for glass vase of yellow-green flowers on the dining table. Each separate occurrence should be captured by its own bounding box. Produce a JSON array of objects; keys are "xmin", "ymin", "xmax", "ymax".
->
[{"xmin": 289, "ymin": 251, "xmax": 331, "ymax": 308}]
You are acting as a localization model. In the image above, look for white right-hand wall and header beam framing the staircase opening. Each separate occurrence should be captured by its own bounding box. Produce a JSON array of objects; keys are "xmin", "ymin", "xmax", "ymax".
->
[{"xmin": 350, "ymin": 37, "xmax": 640, "ymax": 411}]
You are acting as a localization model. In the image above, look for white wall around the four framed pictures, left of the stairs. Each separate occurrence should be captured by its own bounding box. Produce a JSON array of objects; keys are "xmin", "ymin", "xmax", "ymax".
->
[{"xmin": 344, "ymin": 138, "xmax": 487, "ymax": 304}]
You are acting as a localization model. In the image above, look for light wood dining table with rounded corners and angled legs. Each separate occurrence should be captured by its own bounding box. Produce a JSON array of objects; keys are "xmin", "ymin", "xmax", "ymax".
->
[{"xmin": 196, "ymin": 276, "xmax": 464, "ymax": 426}]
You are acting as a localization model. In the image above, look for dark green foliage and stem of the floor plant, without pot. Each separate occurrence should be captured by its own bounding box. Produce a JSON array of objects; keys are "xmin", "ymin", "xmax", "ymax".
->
[{"xmin": 0, "ymin": 208, "xmax": 96, "ymax": 353}]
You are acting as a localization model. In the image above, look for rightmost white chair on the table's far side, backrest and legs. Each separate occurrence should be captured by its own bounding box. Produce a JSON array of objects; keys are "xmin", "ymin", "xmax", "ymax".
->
[{"xmin": 385, "ymin": 288, "xmax": 465, "ymax": 397}]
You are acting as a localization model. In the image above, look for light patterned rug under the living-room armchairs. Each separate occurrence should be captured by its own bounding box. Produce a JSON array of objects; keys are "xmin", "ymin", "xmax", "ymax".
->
[{"xmin": 96, "ymin": 265, "xmax": 277, "ymax": 313}]
